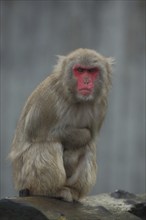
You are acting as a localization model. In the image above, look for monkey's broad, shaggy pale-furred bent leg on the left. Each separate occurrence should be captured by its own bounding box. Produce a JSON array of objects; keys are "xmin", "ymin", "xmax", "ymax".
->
[{"xmin": 13, "ymin": 142, "xmax": 66, "ymax": 196}]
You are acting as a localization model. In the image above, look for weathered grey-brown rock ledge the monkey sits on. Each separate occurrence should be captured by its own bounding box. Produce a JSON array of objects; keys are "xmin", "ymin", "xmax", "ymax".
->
[{"xmin": 0, "ymin": 190, "xmax": 146, "ymax": 220}]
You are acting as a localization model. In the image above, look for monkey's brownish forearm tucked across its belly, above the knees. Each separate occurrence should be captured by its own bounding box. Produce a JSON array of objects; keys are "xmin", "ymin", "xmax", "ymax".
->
[{"xmin": 61, "ymin": 127, "xmax": 91, "ymax": 150}]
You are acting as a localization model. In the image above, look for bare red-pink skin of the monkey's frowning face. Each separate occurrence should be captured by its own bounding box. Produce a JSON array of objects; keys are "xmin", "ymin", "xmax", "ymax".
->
[{"xmin": 73, "ymin": 64, "xmax": 99, "ymax": 96}]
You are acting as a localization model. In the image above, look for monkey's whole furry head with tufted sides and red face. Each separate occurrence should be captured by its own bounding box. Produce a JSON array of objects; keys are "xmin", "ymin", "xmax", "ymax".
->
[{"xmin": 57, "ymin": 49, "xmax": 113, "ymax": 102}]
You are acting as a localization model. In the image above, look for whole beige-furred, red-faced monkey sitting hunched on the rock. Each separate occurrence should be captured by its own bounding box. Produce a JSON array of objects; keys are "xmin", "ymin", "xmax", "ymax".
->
[{"xmin": 10, "ymin": 49, "xmax": 113, "ymax": 201}]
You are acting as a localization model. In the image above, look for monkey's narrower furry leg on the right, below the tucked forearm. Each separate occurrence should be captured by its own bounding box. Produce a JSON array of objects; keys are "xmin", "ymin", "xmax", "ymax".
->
[{"xmin": 67, "ymin": 143, "xmax": 97, "ymax": 200}]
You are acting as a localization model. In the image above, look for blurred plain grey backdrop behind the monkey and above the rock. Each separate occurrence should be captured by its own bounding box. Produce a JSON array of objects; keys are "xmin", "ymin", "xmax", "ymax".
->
[{"xmin": 0, "ymin": 0, "xmax": 146, "ymax": 197}]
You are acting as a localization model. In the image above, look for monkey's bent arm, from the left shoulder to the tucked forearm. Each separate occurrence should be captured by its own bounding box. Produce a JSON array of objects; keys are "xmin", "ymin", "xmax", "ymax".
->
[{"xmin": 19, "ymin": 83, "xmax": 91, "ymax": 149}]
